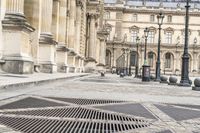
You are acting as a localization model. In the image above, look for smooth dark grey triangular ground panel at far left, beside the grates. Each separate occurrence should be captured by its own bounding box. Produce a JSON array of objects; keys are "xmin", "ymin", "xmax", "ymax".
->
[{"xmin": 0, "ymin": 97, "xmax": 67, "ymax": 109}]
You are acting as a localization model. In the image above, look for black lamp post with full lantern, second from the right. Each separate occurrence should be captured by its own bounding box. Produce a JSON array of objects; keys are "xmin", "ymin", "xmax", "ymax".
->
[{"xmin": 156, "ymin": 12, "xmax": 165, "ymax": 81}]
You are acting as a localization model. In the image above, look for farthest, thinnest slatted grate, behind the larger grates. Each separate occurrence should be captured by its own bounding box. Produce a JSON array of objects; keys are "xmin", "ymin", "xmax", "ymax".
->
[{"xmin": 47, "ymin": 97, "xmax": 124, "ymax": 105}]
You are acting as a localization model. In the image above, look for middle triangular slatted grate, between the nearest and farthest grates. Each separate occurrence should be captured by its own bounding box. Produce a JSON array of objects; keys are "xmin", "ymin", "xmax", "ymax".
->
[{"xmin": 3, "ymin": 107, "xmax": 145, "ymax": 122}]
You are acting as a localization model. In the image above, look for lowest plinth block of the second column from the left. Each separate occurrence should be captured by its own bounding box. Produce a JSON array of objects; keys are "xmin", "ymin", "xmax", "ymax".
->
[{"xmin": 40, "ymin": 64, "xmax": 57, "ymax": 73}]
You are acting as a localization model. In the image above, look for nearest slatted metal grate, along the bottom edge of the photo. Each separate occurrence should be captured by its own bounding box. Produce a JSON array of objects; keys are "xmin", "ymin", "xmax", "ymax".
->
[{"xmin": 0, "ymin": 116, "xmax": 148, "ymax": 133}]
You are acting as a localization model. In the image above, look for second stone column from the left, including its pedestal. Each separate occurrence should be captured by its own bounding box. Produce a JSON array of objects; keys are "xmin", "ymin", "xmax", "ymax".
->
[{"xmin": 40, "ymin": 0, "xmax": 57, "ymax": 73}]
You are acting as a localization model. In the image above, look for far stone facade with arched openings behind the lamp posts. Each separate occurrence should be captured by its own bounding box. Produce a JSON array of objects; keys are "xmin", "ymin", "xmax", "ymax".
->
[{"xmin": 104, "ymin": 0, "xmax": 200, "ymax": 75}]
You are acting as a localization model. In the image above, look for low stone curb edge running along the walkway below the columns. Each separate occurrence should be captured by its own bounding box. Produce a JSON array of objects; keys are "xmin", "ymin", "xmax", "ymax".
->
[{"xmin": 0, "ymin": 74, "xmax": 90, "ymax": 89}]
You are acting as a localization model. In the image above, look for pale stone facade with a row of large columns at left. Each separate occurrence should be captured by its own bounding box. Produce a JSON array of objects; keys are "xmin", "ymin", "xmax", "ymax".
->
[{"xmin": 0, "ymin": 0, "xmax": 107, "ymax": 74}]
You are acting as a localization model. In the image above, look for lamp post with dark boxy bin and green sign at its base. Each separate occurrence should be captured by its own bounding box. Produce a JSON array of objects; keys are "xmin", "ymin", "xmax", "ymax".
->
[{"xmin": 142, "ymin": 28, "xmax": 150, "ymax": 81}]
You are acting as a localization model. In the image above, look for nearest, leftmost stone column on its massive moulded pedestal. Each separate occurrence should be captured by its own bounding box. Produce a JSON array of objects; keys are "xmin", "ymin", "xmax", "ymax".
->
[{"xmin": 2, "ymin": 0, "xmax": 34, "ymax": 74}]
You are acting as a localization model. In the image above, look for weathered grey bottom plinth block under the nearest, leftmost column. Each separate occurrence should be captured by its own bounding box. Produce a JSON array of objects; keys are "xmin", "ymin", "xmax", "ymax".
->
[{"xmin": 2, "ymin": 60, "xmax": 34, "ymax": 74}]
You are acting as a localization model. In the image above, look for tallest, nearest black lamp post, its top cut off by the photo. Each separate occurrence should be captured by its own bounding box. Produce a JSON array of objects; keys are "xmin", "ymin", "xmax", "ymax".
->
[{"xmin": 179, "ymin": 0, "xmax": 191, "ymax": 87}]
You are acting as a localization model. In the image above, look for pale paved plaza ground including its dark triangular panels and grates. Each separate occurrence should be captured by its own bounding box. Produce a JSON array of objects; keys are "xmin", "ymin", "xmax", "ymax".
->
[{"xmin": 0, "ymin": 74, "xmax": 200, "ymax": 133}]
